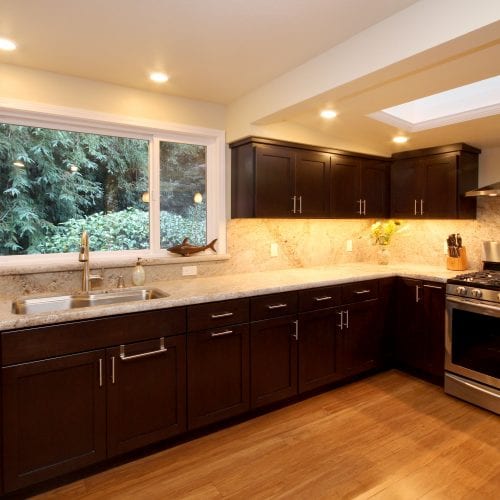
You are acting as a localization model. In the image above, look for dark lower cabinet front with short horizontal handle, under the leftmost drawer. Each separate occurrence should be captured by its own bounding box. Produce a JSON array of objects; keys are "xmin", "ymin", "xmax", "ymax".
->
[{"xmin": 187, "ymin": 325, "xmax": 250, "ymax": 429}]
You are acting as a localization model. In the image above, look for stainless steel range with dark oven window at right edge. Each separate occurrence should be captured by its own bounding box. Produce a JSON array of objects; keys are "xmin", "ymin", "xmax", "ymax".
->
[{"xmin": 444, "ymin": 241, "xmax": 500, "ymax": 414}]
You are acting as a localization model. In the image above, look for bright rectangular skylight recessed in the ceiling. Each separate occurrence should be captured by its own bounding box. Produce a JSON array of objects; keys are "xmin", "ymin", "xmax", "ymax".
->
[{"xmin": 369, "ymin": 76, "xmax": 500, "ymax": 132}]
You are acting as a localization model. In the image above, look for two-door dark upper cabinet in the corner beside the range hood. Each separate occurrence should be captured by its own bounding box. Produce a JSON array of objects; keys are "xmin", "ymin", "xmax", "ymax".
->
[{"xmin": 391, "ymin": 144, "xmax": 480, "ymax": 219}]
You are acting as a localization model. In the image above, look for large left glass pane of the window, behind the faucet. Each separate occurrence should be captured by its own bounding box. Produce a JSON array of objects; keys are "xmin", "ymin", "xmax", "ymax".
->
[{"xmin": 0, "ymin": 123, "xmax": 149, "ymax": 255}]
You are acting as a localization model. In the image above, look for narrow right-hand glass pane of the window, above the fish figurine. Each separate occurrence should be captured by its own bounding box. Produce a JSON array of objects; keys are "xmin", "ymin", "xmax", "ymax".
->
[{"xmin": 160, "ymin": 141, "xmax": 207, "ymax": 248}]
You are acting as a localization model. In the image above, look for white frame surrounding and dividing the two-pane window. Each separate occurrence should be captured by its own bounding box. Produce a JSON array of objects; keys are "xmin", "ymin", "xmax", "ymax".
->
[{"xmin": 0, "ymin": 99, "xmax": 228, "ymax": 270}]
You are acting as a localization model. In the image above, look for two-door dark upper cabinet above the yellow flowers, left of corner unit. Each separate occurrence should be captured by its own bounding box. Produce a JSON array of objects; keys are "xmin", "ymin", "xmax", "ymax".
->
[{"xmin": 331, "ymin": 155, "xmax": 389, "ymax": 219}]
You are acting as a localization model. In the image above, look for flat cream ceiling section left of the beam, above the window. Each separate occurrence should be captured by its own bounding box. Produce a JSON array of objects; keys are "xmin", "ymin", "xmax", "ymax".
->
[{"xmin": 0, "ymin": 0, "xmax": 416, "ymax": 103}]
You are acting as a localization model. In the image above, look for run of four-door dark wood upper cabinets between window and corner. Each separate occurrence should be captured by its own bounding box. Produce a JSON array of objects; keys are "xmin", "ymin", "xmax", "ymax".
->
[{"xmin": 230, "ymin": 137, "xmax": 388, "ymax": 218}]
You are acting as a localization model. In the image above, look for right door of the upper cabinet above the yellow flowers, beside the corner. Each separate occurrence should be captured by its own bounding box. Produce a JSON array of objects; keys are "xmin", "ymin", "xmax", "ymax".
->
[{"xmin": 361, "ymin": 160, "xmax": 389, "ymax": 217}]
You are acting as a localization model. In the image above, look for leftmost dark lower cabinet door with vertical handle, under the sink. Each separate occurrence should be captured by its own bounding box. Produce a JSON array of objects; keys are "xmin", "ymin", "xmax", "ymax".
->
[{"xmin": 2, "ymin": 351, "xmax": 106, "ymax": 492}]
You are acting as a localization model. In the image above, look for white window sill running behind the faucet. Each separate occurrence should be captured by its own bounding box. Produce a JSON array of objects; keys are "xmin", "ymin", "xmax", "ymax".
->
[{"xmin": 0, "ymin": 252, "xmax": 231, "ymax": 276}]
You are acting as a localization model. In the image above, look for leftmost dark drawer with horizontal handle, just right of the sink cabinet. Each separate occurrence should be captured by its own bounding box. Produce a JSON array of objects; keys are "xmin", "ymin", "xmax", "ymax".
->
[{"xmin": 187, "ymin": 299, "xmax": 248, "ymax": 332}]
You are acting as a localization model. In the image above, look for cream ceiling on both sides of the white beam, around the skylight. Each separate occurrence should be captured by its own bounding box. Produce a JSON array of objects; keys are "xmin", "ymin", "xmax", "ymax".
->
[{"xmin": 0, "ymin": 0, "xmax": 500, "ymax": 154}]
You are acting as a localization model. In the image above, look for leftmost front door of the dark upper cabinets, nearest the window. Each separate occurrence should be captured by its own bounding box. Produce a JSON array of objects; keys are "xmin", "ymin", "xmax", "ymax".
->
[{"xmin": 255, "ymin": 146, "xmax": 295, "ymax": 217}]
